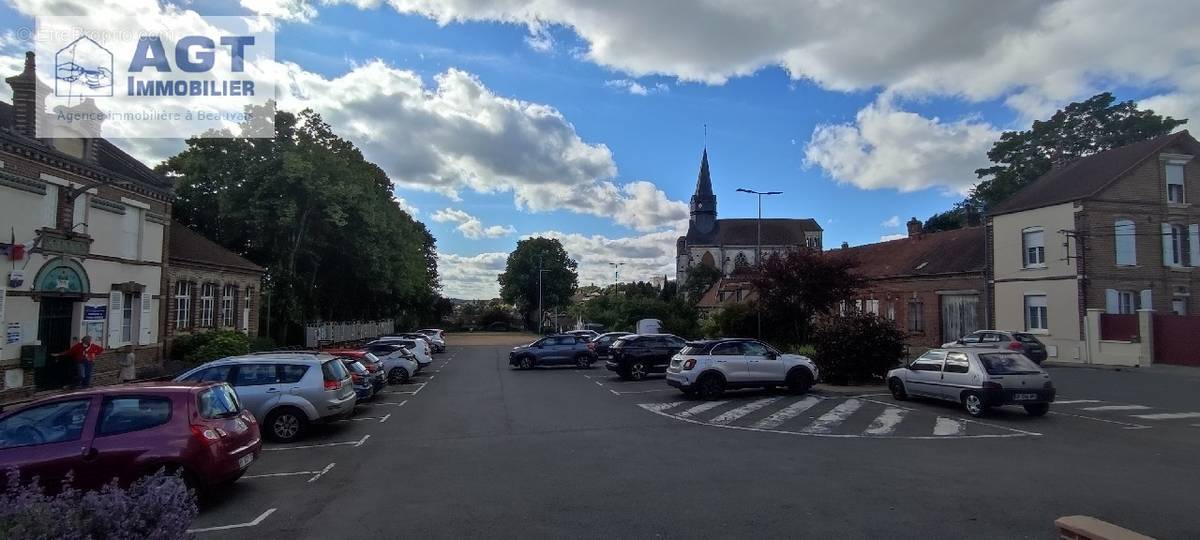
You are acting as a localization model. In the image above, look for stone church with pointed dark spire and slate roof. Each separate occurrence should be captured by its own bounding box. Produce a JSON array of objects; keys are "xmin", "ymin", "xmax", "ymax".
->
[{"xmin": 676, "ymin": 149, "xmax": 822, "ymax": 283}]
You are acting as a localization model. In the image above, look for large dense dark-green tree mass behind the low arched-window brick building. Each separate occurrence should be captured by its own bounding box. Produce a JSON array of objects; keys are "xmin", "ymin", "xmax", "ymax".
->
[{"xmin": 160, "ymin": 109, "xmax": 444, "ymax": 343}]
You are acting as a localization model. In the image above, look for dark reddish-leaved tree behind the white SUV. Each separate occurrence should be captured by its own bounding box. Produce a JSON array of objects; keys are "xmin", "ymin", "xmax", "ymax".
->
[{"xmin": 751, "ymin": 250, "xmax": 863, "ymax": 347}]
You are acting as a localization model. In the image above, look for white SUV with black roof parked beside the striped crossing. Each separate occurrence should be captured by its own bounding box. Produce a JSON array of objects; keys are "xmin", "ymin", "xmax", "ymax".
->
[{"xmin": 667, "ymin": 338, "xmax": 821, "ymax": 400}]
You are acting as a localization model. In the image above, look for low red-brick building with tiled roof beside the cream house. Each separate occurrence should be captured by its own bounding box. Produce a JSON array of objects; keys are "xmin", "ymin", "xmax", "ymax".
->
[{"xmin": 838, "ymin": 222, "xmax": 988, "ymax": 354}]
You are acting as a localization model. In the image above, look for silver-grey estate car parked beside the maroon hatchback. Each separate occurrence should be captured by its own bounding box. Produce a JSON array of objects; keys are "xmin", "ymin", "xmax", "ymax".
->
[{"xmin": 175, "ymin": 350, "xmax": 358, "ymax": 442}]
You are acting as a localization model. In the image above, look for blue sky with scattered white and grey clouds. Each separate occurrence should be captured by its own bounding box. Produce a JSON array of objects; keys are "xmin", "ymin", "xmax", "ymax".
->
[{"xmin": 0, "ymin": 0, "xmax": 1200, "ymax": 298}]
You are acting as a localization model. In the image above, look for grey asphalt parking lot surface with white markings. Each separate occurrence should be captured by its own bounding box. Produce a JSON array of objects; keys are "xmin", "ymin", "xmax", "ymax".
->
[{"xmin": 193, "ymin": 335, "xmax": 1200, "ymax": 539}]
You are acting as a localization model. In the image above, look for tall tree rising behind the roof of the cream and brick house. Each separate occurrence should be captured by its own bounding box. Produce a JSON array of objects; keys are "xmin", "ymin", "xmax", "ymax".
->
[{"xmin": 966, "ymin": 92, "xmax": 1187, "ymax": 210}]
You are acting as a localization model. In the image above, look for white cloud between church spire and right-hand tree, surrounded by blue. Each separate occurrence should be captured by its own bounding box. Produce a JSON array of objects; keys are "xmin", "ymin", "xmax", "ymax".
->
[{"xmin": 804, "ymin": 96, "xmax": 1000, "ymax": 193}]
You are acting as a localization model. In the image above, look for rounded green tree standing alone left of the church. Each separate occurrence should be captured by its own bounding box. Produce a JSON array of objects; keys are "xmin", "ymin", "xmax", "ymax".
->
[{"xmin": 498, "ymin": 236, "xmax": 578, "ymax": 329}]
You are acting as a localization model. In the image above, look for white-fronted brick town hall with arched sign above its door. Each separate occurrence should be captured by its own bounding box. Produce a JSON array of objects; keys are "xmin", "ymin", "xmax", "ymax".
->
[{"xmin": 0, "ymin": 53, "xmax": 173, "ymax": 400}]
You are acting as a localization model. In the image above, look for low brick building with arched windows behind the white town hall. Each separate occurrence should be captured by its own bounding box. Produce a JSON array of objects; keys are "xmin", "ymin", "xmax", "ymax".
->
[{"xmin": 163, "ymin": 222, "xmax": 263, "ymax": 350}]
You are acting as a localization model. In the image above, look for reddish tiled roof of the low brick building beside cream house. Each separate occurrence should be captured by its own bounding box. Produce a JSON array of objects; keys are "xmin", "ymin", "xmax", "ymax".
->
[{"xmin": 832, "ymin": 227, "xmax": 986, "ymax": 280}]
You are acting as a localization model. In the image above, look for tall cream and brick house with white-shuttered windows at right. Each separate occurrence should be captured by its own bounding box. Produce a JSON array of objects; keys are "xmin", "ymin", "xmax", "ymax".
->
[{"xmin": 988, "ymin": 131, "xmax": 1200, "ymax": 362}]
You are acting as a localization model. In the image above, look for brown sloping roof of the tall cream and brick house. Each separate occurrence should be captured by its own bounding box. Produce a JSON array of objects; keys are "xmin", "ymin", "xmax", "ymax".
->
[{"xmin": 988, "ymin": 130, "xmax": 1198, "ymax": 216}]
